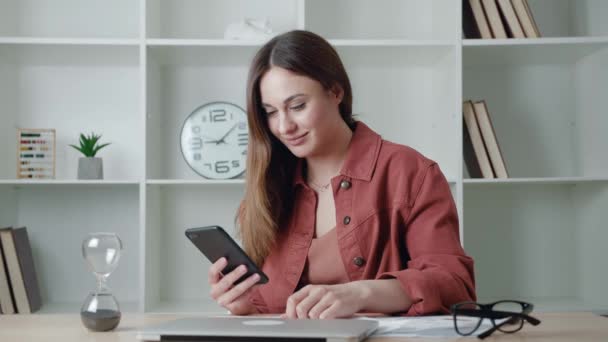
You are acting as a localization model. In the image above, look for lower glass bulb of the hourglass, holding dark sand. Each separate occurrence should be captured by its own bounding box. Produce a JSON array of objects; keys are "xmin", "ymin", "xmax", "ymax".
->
[{"xmin": 80, "ymin": 293, "xmax": 121, "ymax": 331}]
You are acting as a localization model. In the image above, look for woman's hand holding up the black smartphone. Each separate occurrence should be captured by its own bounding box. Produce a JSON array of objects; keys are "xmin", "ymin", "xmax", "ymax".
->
[{"xmin": 209, "ymin": 258, "xmax": 260, "ymax": 315}]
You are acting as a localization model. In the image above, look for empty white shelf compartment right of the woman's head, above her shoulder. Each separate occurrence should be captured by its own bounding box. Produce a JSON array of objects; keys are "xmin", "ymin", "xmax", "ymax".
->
[{"xmin": 337, "ymin": 46, "xmax": 460, "ymax": 179}]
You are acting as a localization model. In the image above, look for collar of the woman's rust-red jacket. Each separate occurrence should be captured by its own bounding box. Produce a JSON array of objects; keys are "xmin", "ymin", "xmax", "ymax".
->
[{"xmin": 293, "ymin": 121, "xmax": 382, "ymax": 186}]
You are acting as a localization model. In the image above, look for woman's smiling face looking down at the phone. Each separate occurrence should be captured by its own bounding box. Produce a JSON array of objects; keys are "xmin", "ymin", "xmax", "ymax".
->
[{"xmin": 260, "ymin": 67, "xmax": 344, "ymax": 158}]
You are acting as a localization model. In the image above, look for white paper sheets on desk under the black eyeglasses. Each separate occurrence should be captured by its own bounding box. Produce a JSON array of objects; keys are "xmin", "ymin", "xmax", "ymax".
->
[{"xmin": 358, "ymin": 315, "xmax": 492, "ymax": 337}]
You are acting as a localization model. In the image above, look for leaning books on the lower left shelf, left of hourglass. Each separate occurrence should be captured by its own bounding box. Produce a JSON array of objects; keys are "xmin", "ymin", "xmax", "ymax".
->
[{"xmin": 0, "ymin": 227, "xmax": 42, "ymax": 314}]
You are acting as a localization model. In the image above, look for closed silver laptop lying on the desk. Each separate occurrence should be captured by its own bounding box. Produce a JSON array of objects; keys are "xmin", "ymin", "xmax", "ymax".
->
[{"xmin": 137, "ymin": 316, "xmax": 378, "ymax": 342}]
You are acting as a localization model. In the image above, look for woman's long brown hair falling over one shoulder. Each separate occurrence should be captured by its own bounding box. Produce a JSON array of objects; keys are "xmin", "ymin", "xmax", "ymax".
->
[{"xmin": 236, "ymin": 30, "xmax": 355, "ymax": 265}]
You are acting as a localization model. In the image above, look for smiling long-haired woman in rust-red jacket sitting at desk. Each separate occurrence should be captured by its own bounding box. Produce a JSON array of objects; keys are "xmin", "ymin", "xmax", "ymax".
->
[{"xmin": 209, "ymin": 31, "xmax": 475, "ymax": 318}]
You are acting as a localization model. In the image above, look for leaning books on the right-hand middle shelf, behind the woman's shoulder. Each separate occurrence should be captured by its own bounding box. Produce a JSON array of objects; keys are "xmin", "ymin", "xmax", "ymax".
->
[{"xmin": 462, "ymin": 100, "xmax": 509, "ymax": 178}]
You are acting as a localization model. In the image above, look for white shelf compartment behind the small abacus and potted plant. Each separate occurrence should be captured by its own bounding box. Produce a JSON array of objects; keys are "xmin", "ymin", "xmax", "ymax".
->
[{"xmin": 0, "ymin": 44, "xmax": 143, "ymax": 180}]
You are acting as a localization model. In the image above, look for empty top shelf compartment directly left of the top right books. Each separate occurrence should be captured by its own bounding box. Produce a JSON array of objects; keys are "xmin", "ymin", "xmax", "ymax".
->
[{"xmin": 305, "ymin": 0, "xmax": 460, "ymax": 39}]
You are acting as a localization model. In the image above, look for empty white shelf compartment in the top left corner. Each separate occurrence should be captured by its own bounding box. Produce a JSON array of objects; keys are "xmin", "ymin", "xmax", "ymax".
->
[{"xmin": 0, "ymin": 0, "xmax": 140, "ymax": 38}]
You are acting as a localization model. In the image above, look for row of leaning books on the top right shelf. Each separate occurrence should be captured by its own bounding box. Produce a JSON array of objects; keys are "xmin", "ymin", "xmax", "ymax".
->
[{"xmin": 462, "ymin": 0, "xmax": 540, "ymax": 39}]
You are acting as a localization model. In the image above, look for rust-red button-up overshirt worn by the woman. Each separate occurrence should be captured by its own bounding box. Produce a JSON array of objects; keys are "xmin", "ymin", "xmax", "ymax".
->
[{"xmin": 250, "ymin": 122, "xmax": 476, "ymax": 315}]
